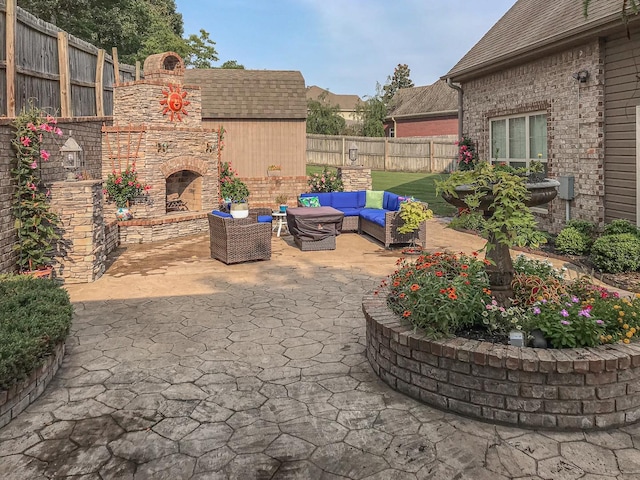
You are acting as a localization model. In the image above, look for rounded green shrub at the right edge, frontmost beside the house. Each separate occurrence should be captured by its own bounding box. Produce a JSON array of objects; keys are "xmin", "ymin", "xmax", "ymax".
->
[{"xmin": 590, "ymin": 233, "xmax": 640, "ymax": 273}]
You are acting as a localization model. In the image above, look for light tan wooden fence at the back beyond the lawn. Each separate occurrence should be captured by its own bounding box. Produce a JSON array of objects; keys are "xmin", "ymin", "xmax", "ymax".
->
[{"xmin": 307, "ymin": 134, "xmax": 458, "ymax": 173}]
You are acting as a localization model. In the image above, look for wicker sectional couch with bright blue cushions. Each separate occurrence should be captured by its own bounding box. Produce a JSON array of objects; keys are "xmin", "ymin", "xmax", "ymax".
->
[{"xmin": 299, "ymin": 190, "xmax": 427, "ymax": 248}]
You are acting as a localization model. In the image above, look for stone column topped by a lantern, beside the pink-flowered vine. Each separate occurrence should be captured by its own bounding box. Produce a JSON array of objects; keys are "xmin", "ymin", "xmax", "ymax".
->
[{"xmin": 51, "ymin": 180, "xmax": 106, "ymax": 283}]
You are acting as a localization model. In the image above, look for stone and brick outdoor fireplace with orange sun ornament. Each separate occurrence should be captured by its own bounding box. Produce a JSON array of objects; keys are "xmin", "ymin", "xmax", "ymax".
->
[{"xmin": 102, "ymin": 52, "xmax": 218, "ymax": 221}]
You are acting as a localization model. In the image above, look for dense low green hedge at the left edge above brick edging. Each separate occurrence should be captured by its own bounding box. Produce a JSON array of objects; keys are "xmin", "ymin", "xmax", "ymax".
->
[{"xmin": 0, "ymin": 275, "xmax": 73, "ymax": 390}]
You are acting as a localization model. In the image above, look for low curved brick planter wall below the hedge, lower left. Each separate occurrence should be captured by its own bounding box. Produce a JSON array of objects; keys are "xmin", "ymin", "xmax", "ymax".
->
[{"xmin": 0, "ymin": 342, "xmax": 64, "ymax": 428}]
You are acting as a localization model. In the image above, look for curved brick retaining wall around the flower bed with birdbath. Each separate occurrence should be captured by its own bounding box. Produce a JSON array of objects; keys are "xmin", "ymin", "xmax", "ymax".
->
[{"xmin": 362, "ymin": 294, "xmax": 640, "ymax": 429}]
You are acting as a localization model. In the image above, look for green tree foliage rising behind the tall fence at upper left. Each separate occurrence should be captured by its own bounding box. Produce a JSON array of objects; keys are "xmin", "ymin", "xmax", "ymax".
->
[{"xmin": 18, "ymin": 0, "xmax": 228, "ymax": 68}]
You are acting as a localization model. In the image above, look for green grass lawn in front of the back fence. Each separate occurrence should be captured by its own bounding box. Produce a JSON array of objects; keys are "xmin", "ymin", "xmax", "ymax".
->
[{"xmin": 307, "ymin": 165, "xmax": 456, "ymax": 217}]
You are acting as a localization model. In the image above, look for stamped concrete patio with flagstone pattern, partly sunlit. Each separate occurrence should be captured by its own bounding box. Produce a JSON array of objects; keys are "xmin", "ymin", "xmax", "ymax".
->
[{"xmin": 0, "ymin": 220, "xmax": 640, "ymax": 480}]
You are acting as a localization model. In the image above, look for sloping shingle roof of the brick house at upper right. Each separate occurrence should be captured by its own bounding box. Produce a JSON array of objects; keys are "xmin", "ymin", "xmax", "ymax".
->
[{"xmin": 445, "ymin": 0, "xmax": 636, "ymax": 81}]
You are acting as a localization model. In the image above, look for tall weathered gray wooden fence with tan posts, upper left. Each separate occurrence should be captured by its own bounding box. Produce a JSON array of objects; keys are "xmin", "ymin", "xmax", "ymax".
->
[{"xmin": 0, "ymin": 0, "xmax": 140, "ymax": 118}]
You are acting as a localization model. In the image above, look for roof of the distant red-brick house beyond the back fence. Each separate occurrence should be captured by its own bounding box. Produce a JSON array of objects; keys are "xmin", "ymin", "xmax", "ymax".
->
[{"xmin": 387, "ymin": 80, "xmax": 458, "ymax": 118}]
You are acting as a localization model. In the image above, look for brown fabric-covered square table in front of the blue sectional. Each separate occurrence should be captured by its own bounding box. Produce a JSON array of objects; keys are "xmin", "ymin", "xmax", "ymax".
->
[{"xmin": 287, "ymin": 207, "xmax": 344, "ymax": 251}]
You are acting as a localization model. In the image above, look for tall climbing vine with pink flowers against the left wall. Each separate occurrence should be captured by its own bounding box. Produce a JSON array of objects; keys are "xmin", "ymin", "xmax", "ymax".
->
[{"xmin": 11, "ymin": 105, "xmax": 62, "ymax": 277}]
